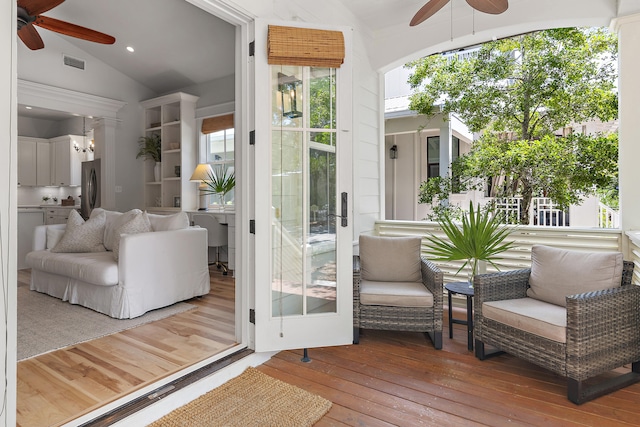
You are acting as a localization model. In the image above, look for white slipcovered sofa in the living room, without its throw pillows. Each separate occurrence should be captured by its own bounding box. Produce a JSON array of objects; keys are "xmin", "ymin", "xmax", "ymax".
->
[{"xmin": 25, "ymin": 211, "xmax": 210, "ymax": 319}]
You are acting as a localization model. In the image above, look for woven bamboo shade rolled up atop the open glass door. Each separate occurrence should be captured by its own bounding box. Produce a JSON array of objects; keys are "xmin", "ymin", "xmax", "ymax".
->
[{"xmin": 267, "ymin": 25, "xmax": 344, "ymax": 68}]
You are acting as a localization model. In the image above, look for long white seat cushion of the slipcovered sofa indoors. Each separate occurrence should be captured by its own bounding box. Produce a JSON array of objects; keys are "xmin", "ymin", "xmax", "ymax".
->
[{"xmin": 25, "ymin": 251, "xmax": 118, "ymax": 286}]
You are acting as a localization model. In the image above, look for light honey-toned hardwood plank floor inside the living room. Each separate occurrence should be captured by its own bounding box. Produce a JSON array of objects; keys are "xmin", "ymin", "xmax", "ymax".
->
[{"xmin": 17, "ymin": 267, "xmax": 235, "ymax": 427}]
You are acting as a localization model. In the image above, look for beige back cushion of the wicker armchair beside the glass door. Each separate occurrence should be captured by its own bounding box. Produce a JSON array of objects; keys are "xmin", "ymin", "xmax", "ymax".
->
[{"xmin": 360, "ymin": 235, "xmax": 422, "ymax": 282}]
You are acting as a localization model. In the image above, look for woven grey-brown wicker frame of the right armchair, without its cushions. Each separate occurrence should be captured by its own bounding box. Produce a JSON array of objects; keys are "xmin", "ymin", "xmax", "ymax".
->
[{"xmin": 474, "ymin": 252, "xmax": 640, "ymax": 404}]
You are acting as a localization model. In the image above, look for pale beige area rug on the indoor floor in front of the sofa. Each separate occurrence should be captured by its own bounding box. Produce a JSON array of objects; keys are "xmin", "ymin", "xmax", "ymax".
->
[{"xmin": 17, "ymin": 286, "xmax": 196, "ymax": 360}]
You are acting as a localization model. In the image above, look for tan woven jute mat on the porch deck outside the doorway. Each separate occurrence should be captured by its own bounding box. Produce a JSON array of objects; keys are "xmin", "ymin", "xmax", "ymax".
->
[{"xmin": 149, "ymin": 368, "xmax": 331, "ymax": 427}]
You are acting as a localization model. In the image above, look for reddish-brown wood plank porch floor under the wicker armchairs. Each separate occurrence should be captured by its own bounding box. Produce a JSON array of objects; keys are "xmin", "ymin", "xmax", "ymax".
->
[{"xmin": 258, "ymin": 309, "xmax": 640, "ymax": 427}]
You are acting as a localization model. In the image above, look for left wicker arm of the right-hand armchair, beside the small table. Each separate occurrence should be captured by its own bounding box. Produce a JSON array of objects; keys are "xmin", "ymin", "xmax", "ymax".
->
[{"xmin": 473, "ymin": 268, "xmax": 531, "ymax": 305}]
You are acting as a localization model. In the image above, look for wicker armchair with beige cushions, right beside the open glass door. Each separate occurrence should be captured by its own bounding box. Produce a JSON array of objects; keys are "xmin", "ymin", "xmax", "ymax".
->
[{"xmin": 353, "ymin": 236, "xmax": 443, "ymax": 350}]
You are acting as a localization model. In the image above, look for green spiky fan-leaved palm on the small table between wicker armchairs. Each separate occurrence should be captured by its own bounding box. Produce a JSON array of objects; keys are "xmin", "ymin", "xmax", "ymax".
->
[{"xmin": 426, "ymin": 202, "xmax": 514, "ymax": 286}]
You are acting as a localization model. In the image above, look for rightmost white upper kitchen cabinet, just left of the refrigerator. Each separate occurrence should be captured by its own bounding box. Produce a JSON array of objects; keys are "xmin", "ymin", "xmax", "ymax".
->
[{"xmin": 49, "ymin": 135, "xmax": 84, "ymax": 187}]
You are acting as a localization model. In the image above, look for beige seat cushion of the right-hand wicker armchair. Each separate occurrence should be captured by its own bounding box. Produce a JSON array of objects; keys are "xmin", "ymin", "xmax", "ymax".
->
[{"xmin": 482, "ymin": 298, "xmax": 567, "ymax": 343}]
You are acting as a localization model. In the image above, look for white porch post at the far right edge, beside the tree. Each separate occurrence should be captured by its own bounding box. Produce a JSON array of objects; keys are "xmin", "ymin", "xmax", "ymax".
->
[{"xmin": 612, "ymin": 14, "xmax": 640, "ymax": 247}]
